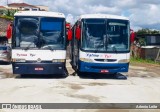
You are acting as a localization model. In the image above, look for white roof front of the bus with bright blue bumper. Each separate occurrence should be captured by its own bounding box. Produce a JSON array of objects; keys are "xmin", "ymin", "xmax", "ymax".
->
[{"xmin": 80, "ymin": 14, "xmax": 129, "ymax": 20}]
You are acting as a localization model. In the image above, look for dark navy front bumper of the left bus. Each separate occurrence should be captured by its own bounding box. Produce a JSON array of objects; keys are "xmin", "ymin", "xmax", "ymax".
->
[{"xmin": 12, "ymin": 62, "xmax": 66, "ymax": 74}]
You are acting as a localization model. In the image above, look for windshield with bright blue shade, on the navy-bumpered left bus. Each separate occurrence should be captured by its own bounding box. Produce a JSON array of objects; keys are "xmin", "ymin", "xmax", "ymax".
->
[{"xmin": 15, "ymin": 17, "xmax": 65, "ymax": 49}]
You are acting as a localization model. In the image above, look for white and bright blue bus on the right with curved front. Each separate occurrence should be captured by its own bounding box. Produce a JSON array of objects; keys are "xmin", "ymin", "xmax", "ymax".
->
[{"xmin": 70, "ymin": 14, "xmax": 130, "ymax": 74}]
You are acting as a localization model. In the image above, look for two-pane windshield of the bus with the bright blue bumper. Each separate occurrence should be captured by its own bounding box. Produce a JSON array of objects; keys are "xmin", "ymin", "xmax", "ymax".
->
[{"xmin": 81, "ymin": 19, "xmax": 130, "ymax": 52}]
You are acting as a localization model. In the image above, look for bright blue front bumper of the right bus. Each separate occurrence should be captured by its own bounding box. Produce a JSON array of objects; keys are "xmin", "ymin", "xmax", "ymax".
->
[{"xmin": 79, "ymin": 61, "xmax": 129, "ymax": 73}]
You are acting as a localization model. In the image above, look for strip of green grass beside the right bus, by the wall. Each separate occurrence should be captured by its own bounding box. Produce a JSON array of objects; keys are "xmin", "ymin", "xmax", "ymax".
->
[{"xmin": 130, "ymin": 57, "xmax": 160, "ymax": 65}]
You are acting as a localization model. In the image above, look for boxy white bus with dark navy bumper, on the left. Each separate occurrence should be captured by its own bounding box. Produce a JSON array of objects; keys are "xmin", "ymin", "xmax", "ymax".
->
[{"xmin": 12, "ymin": 11, "xmax": 70, "ymax": 75}]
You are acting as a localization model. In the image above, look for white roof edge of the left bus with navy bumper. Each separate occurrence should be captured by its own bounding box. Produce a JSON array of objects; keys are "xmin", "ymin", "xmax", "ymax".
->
[{"xmin": 14, "ymin": 11, "xmax": 65, "ymax": 18}]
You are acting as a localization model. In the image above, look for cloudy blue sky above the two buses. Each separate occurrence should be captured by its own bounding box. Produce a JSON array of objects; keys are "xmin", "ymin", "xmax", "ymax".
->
[{"xmin": 0, "ymin": 0, "xmax": 160, "ymax": 31}]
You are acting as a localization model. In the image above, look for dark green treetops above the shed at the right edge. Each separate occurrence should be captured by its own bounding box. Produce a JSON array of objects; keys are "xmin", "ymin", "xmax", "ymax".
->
[{"xmin": 136, "ymin": 28, "xmax": 160, "ymax": 35}]
